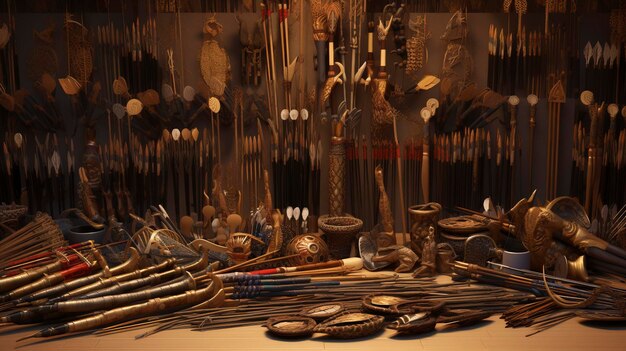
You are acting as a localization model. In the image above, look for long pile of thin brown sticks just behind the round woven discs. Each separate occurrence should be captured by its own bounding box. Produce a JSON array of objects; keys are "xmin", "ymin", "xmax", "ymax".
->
[{"xmin": 97, "ymin": 272, "xmax": 533, "ymax": 338}]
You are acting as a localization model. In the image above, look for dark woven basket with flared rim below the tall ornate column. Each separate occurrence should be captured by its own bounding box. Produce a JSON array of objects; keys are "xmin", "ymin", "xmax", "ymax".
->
[{"xmin": 317, "ymin": 216, "xmax": 363, "ymax": 259}]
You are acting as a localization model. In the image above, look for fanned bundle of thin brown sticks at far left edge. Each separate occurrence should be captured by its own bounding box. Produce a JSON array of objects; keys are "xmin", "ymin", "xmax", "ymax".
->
[{"xmin": 0, "ymin": 213, "xmax": 67, "ymax": 268}]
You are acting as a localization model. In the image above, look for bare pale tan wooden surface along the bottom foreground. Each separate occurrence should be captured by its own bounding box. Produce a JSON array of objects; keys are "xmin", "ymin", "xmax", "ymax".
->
[{"xmin": 0, "ymin": 277, "xmax": 626, "ymax": 351}]
